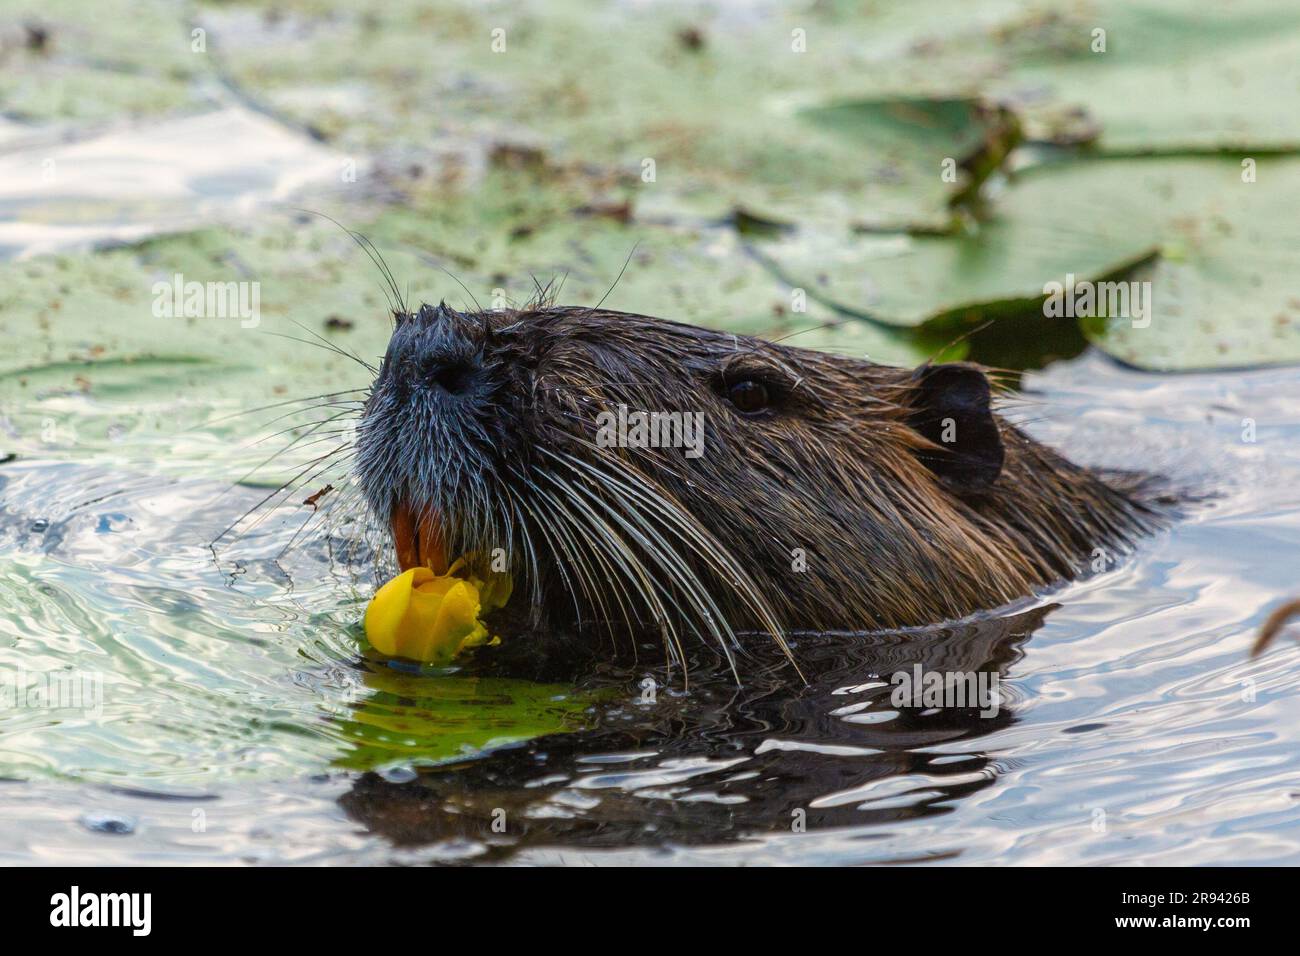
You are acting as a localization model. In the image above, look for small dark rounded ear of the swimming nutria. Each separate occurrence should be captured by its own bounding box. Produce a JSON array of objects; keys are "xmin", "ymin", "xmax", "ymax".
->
[{"xmin": 907, "ymin": 363, "xmax": 1006, "ymax": 494}]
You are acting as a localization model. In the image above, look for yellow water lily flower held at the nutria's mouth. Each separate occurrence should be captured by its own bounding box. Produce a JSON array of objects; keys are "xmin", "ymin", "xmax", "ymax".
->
[{"xmin": 365, "ymin": 558, "xmax": 512, "ymax": 663}]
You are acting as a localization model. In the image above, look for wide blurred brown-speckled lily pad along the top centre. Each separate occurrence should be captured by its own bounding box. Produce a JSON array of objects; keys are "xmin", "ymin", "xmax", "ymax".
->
[{"xmin": 189, "ymin": 0, "xmax": 1024, "ymax": 230}]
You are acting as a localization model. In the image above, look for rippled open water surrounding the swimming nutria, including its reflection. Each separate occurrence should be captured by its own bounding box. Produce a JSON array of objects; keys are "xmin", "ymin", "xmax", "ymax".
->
[{"xmin": 0, "ymin": 354, "xmax": 1300, "ymax": 865}]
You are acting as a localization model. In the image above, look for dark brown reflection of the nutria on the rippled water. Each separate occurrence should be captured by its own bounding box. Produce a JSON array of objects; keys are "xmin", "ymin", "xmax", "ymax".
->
[{"xmin": 342, "ymin": 607, "xmax": 1050, "ymax": 858}]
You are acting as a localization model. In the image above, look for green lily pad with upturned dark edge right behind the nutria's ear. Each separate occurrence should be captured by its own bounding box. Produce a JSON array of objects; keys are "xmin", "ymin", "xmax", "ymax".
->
[{"xmin": 758, "ymin": 157, "xmax": 1300, "ymax": 369}]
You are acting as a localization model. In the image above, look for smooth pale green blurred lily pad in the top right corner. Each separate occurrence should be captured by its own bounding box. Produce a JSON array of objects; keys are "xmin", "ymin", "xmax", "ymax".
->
[{"xmin": 982, "ymin": 0, "xmax": 1300, "ymax": 153}]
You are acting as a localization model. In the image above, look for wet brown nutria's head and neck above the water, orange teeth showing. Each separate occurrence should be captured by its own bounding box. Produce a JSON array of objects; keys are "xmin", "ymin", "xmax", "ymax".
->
[{"xmin": 356, "ymin": 304, "xmax": 1160, "ymax": 660}]
